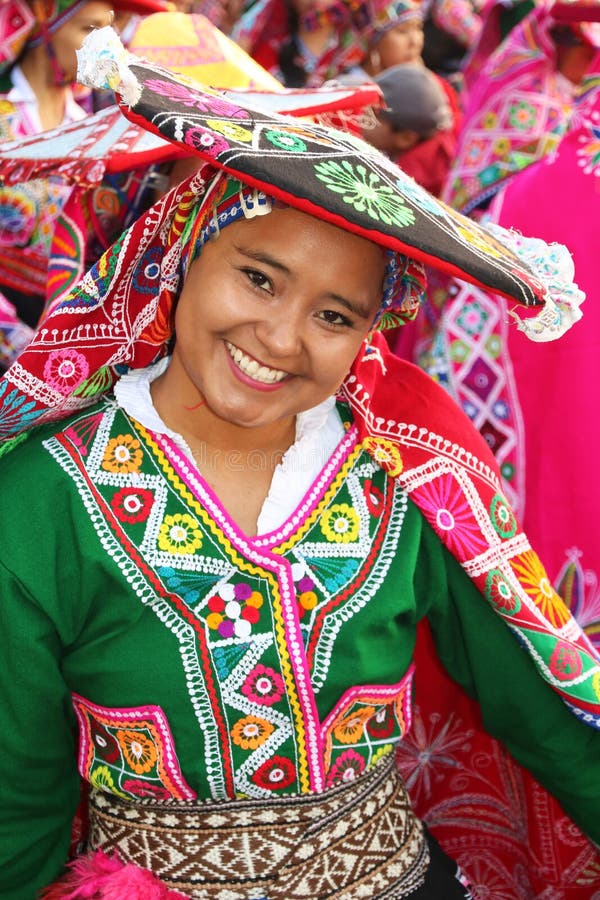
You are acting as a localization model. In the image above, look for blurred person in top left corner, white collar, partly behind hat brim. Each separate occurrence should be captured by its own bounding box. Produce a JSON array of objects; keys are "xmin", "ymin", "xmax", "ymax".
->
[{"xmin": 0, "ymin": 0, "xmax": 165, "ymax": 358}]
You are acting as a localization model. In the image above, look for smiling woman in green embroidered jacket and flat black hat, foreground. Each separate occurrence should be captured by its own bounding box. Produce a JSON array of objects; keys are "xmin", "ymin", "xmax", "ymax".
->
[{"xmin": 0, "ymin": 26, "xmax": 600, "ymax": 900}]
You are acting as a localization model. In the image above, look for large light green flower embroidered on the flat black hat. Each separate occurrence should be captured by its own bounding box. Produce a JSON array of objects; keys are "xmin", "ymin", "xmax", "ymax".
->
[{"xmin": 315, "ymin": 160, "xmax": 415, "ymax": 228}]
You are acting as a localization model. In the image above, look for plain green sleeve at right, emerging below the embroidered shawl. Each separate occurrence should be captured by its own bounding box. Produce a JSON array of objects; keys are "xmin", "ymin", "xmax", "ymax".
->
[{"xmin": 419, "ymin": 523, "xmax": 600, "ymax": 843}]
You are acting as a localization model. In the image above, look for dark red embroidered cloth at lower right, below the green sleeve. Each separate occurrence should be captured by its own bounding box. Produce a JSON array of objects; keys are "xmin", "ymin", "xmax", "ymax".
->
[{"xmin": 396, "ymin": 623, "xmax": 600, "ymax": 900}]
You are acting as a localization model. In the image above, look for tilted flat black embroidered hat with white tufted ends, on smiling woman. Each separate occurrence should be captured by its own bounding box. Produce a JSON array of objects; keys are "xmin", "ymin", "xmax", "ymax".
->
[{"xmin": 78, "ymin": 28, "xmax": 583, "ymax": 339}]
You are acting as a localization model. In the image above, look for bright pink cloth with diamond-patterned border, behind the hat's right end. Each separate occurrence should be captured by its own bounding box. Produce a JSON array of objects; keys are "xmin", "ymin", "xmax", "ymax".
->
[{"xmin": 417, "ymin": 54, "xmax": 600, "ymax": 646}]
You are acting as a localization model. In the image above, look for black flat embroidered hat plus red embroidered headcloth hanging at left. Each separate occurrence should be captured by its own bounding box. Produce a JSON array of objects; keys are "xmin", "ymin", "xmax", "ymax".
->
[{"xmin": 0, "ymin": 29, "xmax": 583, "ymax": 448}]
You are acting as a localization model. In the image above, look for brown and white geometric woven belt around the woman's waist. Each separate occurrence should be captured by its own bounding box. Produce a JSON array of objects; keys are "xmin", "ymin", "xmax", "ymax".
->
[{"xmin": 89, "ymin": 760, "xmax": 429, "ymax": 900}]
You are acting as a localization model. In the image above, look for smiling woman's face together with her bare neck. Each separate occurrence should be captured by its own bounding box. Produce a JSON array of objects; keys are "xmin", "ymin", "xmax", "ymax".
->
[{"xmin": 151, "ymin": 197, "xmax": 386, "ymax": 534}]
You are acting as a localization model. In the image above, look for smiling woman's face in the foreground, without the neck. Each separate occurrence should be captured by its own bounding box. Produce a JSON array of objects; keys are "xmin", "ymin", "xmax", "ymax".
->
[{"xmin": 168, "ymin": 208, "xmax": 385, "ymax": 427}]
